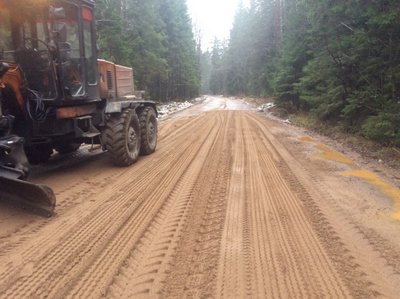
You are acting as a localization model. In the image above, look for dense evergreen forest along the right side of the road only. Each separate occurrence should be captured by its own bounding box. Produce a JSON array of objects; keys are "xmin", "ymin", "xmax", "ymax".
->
[{"xmin": 202, "ymin": 0, "xmax": 400, "ymax": 147}]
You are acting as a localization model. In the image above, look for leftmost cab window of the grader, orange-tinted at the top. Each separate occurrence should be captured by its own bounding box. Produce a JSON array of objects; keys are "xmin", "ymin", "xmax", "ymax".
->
[{"xmin": 0, "ymin": 0, "xmax": 57, "ymax": 99}]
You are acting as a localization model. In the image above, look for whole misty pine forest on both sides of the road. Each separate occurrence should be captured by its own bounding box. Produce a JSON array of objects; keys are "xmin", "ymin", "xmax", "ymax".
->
[{"xmin": 97, "ymin": 0, "xmax": 400, "ymax": 146}]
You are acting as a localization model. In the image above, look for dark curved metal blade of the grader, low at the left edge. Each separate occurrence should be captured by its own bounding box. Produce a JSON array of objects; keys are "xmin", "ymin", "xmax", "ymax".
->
[{"xmin": 0, "ymin": 176, "xmax": 56, "ymax": 217}]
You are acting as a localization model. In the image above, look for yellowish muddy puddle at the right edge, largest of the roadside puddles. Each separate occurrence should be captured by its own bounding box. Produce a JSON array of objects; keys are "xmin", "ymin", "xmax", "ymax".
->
[{"xmin": 342, "ymin": 170, "xmax": 400, "ymax": 220}]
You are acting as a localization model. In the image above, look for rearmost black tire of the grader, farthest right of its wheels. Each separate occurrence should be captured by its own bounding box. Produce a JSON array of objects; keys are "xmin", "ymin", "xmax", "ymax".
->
[{"xmin": 139, "ymin": 107, "xmax": 158, "ymax": 155}]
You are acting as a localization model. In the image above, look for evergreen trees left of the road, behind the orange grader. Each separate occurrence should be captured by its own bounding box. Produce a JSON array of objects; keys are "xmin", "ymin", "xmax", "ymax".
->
[{"xmin": 97, "ymin": 0, "xmax": 200, "ymax": 101}]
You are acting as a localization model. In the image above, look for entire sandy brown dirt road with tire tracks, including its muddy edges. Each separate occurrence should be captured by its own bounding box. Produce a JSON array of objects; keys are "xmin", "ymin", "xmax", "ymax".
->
[{"xmin": 0, "ymin": 98, "xmax": 400, "ymax": 298}]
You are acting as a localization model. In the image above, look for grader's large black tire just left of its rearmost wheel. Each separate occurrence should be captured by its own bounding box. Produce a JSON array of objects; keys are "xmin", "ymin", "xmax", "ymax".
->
[{"xmin": 105, "ymin": 109, "xmax": 140, "ymax": 166}]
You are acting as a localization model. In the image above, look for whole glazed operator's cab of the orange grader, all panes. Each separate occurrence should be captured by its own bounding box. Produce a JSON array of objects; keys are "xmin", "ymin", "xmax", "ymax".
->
[{"xmin": 0, "ymin": 0, "xmax": 93, "ymax": 99}]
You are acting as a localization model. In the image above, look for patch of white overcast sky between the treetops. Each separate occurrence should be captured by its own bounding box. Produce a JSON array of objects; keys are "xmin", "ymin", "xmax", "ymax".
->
[{"xmin": 187, "ymin": 0, "xmax": 246, "ymax": 50}]
